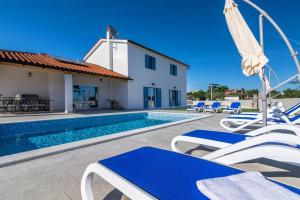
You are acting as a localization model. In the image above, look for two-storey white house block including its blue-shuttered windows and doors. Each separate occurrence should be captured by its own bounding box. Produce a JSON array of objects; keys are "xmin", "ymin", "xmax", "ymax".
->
[{"xmin": 84, "ymin": 39, "xmax": 188, "ymax": 109}]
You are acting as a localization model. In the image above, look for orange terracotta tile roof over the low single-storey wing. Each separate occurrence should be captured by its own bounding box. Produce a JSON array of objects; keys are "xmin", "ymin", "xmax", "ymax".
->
[{"xmin": 0, "ymin": 50, "xmax": 129, "ymax": 79}]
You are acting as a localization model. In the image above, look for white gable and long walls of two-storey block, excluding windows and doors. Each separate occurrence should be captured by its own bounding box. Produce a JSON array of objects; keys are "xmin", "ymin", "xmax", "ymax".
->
[{"xmin": 86, "ymin": 40, "xmax": 187, "ymax": 109}]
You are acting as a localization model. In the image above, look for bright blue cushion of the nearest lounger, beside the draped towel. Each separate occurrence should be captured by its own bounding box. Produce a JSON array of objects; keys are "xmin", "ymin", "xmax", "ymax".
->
[{"xmin": 99, "ymin": 147, "xmax": 300, "ymax": 200}]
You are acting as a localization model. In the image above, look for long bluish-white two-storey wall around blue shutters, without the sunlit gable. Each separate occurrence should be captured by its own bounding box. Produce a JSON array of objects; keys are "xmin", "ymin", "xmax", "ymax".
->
[{"xmin": 128, "ymin": 43, "xmax": 187, "ymax": 109}]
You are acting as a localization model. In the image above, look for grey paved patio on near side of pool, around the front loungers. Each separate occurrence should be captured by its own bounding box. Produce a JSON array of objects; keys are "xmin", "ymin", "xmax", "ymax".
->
[{"xmin": 0, "ymin": 114, "xmax": 300, "ymax": 200}]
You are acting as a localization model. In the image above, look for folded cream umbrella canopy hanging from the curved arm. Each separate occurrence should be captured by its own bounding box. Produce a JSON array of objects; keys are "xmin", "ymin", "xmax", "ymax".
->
[{"xmin": 224, "ymin": 0, "xmax": 269, "ymax": 79}]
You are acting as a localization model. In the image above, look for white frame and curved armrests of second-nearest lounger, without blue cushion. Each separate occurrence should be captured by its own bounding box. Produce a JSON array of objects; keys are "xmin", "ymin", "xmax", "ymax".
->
[{"xmin": 171, "ymin": 125, "xmax": 300, "ymax": 165}]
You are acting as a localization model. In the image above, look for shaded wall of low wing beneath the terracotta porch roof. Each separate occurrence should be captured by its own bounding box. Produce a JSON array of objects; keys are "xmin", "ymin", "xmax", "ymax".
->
[{"xmin": 0, "ymin": 65, "xmax": 128, "ymax": 111}]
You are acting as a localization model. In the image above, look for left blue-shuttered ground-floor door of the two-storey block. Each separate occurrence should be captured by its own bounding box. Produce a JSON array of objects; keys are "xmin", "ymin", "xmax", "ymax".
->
[{"xmin": 144, "ymin": 87, "xmax": 161, "ymax": 108}]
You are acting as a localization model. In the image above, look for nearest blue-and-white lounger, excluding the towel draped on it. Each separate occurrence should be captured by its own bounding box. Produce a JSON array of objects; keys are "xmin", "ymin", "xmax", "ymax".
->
[{"xmin": 81, "ymin": 147, "xmax": 300, "ymax": 200}]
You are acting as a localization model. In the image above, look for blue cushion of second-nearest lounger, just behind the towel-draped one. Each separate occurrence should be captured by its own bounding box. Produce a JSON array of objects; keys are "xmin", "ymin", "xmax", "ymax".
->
[{"xmin": 183, "ymin": 130, "xmax": 249, "ymax": 144}]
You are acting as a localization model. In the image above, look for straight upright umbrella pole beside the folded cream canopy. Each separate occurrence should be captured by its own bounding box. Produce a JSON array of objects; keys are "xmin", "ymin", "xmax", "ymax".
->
[{"xmin": 259, "ymin": 14, "xmax": 268, "ymax": 126}]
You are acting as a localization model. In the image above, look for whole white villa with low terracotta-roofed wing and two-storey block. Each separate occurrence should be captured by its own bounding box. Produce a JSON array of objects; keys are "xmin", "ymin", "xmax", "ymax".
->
[{"xmin": 0, "ymin": 27, "xmax": 188, "ymax": 112}]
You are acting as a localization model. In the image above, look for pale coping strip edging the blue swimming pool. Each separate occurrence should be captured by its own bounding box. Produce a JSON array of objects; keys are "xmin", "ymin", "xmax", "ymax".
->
[{"xmin": 0, "ymin": 111, "xmax": 214, "ymax": 168}]
